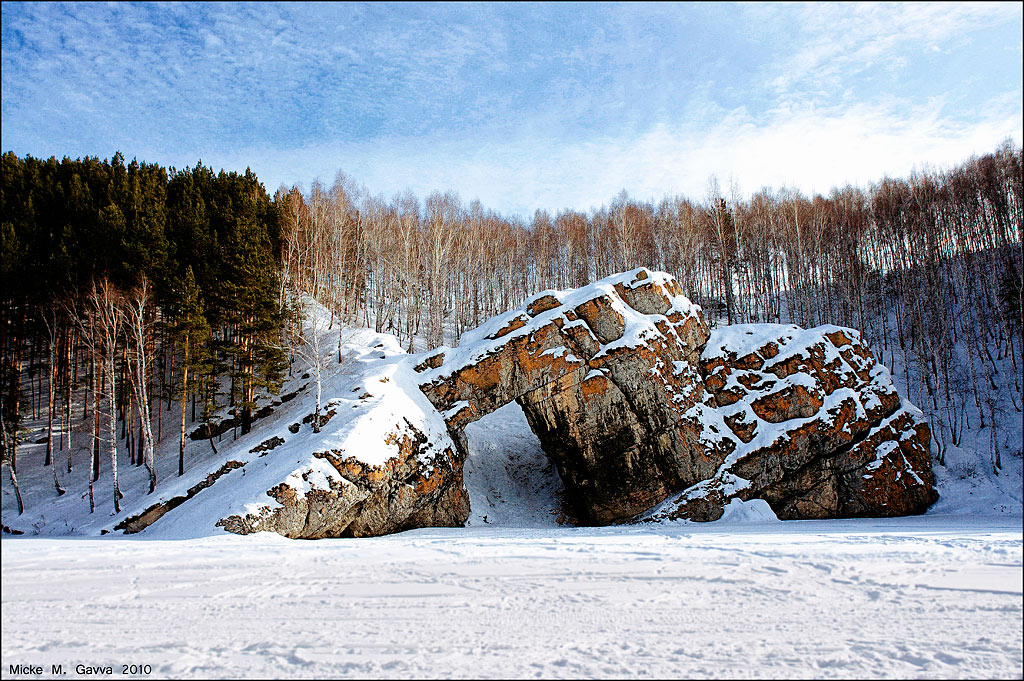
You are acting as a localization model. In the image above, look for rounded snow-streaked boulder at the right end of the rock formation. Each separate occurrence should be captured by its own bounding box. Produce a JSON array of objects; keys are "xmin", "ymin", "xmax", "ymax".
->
[{"xmin": 647, "ymin": 325, "xmax": 937, "ymax": 520}]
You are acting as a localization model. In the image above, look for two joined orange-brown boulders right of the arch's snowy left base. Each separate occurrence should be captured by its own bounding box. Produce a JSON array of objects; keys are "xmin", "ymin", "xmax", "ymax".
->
[{"xmin": 417, "ymin": 269, "xmax": 936, "ymax": 524}]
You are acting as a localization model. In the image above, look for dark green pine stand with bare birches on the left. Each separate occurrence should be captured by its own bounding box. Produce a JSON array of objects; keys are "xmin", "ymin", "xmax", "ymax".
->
[{"xmin": 0, "ymin": 153, "xmax": 286, "ymax": 510}]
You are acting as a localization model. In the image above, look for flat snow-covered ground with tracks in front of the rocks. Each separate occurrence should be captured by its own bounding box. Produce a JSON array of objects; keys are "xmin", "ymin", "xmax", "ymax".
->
[{"xmin": 2, "ymin": 516, "xmax": 1022, "ymax": 678}]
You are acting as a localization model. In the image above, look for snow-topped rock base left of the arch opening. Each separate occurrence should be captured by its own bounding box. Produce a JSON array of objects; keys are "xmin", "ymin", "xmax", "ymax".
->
[{"xmin": 217, "ymin": 336, "xmax": 469, "ymax": 539}]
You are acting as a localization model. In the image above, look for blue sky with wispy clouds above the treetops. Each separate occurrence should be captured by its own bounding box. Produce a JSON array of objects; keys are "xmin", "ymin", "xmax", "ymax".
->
[{"xmin": 0, "ymin": 2, "xmax": 1024, "ymax": 217}]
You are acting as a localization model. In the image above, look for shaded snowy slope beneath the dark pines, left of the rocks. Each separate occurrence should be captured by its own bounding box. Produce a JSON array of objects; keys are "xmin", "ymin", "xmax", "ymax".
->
[{"xmin": 3, "ymin": 315, "xmax": 407, "ymax": 538}]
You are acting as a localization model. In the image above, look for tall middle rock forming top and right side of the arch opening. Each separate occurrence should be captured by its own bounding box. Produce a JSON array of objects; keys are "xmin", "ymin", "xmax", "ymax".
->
[{"xmin": 416, "ymin": 269, "xmax": 720, "ymax": 524}]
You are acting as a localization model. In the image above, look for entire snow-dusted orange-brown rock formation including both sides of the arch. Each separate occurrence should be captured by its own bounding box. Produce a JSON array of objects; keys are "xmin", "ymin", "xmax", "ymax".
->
[{"xmin": 219, "ymin": 269, "xmax": 937, "ymax": 538}]
